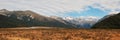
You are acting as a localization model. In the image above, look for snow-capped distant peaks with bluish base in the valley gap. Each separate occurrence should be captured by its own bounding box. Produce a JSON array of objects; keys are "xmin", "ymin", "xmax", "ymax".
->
[{"xmin": 65, "ymin": 17, "xmax": 98, "ymax": 28}]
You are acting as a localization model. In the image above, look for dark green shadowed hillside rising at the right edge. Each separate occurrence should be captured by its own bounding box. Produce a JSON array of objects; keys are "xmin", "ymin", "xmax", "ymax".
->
[{"xmin": 92, "ymin": 13, "xmax": 120, "ymax": 29}]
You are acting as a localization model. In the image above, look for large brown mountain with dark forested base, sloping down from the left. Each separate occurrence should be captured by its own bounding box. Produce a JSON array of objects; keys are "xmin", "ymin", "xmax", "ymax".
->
[{"xmin": 0, "ymin": 9, "xmax": 75, "ymax": 28}]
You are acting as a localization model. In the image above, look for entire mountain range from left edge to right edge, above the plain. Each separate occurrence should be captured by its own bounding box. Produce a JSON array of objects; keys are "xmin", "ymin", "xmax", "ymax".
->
[{"xmin": 0, "ymin": 9, "xmax": 120, "ymax": 28}]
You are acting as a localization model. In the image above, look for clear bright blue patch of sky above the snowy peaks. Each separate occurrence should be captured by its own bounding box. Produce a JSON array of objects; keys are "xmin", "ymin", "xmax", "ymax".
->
[{"xmin": 65, "ymin": 6, "xmax": 110, "ymax": 18}]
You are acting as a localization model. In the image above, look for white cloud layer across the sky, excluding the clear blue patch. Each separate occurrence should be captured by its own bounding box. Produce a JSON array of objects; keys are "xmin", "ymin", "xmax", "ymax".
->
[{"xmin": 0, "ymin": 0, "xmax": 120, "ymax": 15}]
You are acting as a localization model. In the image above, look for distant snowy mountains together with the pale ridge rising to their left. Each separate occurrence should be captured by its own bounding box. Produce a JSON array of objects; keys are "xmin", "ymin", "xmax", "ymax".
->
[{"xmin": 51, "ymin": 16, "xmax": 98, "ymax": 28}]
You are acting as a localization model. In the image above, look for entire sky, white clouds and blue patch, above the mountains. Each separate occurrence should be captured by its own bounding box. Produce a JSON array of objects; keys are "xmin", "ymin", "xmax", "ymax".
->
[{"xmin": 0, "ymin": 0, "xmax": 120, "ymax": 18}]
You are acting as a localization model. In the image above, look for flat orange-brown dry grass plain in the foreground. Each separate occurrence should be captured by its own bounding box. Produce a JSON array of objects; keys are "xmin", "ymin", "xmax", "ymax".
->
[{"xmin": 0, "ymin": 28, "xmax": 120, "ymax": 40}]
